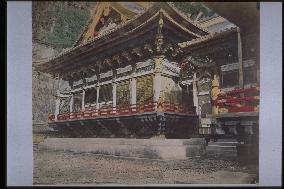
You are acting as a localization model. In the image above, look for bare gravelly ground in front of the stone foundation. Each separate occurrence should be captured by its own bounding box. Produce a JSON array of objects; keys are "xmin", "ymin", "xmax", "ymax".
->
[{"xmin": 34, "ymin": 150, "xmax": 257, "ymax": 185}]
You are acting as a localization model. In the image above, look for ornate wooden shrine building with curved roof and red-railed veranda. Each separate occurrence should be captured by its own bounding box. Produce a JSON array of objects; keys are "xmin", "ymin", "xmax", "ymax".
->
[{"xmin": 34, "ymin": 2, "xmax": 255, "ymax": 138}]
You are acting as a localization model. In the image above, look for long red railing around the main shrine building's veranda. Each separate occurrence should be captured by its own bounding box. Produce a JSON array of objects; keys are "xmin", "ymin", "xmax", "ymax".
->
[{"xmin": 49, "ymin": 101, "xmax": 196, "ymax": 121}]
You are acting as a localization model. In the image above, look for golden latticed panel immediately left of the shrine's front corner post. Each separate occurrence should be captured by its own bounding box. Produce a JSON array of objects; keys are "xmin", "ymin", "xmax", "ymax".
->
[{"xmin": 136, "ymin": 75, "xmax": 153, "ymax": 103}]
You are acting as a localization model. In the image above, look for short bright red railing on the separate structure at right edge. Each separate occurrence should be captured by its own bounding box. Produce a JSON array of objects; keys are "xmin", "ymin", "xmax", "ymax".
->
[{"xmin": 213, "ymin": 87, "xmax": 259, "ymax": 113}]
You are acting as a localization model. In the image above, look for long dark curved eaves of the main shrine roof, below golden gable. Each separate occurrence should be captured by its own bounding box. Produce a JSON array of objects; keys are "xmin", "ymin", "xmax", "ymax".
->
[{"xmin": 35, "ymin": 2, "xmax": 209, "ymax": 73}]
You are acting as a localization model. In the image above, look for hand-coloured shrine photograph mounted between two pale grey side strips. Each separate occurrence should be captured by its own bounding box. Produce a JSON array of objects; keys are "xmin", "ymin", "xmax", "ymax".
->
[{"xmin": 32, "ymin": 1, "xmax": 260, "ymax": 186}]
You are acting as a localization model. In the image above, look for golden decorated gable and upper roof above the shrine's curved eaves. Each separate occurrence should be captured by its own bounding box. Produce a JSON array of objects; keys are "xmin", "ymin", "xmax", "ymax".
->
[{"xmin": 73, "ymin": 2, "xmax": 207, "ymax": 47}]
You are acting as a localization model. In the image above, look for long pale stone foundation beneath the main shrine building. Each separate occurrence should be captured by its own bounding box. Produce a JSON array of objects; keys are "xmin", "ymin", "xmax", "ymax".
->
[{"xmin": 38, "ymin": 138, "xmax": 206, "ymax": 160}]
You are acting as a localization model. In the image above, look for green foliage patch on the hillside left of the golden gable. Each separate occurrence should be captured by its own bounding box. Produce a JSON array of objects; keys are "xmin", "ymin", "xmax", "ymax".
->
[{"xmin": 47, "ymin": 7, "xmax": 89, "ymax": 48}]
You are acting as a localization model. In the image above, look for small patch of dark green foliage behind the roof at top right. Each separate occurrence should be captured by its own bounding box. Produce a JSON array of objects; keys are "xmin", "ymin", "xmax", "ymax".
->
[{"xmin": 174, "ymin": 2, "xmax": 215, "ymax": 17}]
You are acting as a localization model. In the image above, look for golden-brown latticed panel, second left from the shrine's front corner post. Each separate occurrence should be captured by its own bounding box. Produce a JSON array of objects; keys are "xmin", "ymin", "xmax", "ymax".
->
[{"xmin": 116, "ymin": 80, "xmax": 130, "ymax": 106}]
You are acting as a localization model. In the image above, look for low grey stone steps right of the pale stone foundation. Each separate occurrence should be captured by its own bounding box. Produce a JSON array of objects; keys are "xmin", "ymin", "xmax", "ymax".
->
[{"xmin": 206, "ymin": 139, "xmax": 238, "ymax": 159}]
